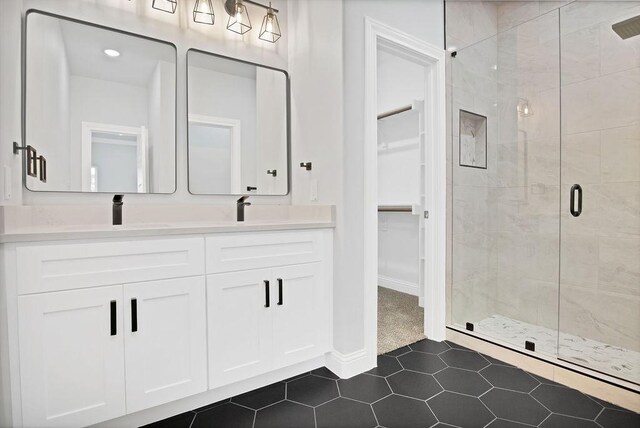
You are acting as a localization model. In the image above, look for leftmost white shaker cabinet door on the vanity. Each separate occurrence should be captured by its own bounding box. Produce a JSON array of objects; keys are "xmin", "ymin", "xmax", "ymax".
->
[{"xmin": 18, "ymin": 286, "xmax": 125, "ymax": 427}]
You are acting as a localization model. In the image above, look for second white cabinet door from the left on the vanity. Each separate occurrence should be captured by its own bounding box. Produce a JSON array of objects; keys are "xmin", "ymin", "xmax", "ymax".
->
[{"xmin": 124, "ymin": 276, "xmax": 207, "ymax": 413}]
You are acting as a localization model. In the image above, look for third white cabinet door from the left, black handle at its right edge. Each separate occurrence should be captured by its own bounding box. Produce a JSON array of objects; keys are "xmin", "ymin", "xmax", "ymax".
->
[{"xmin": 207, "ymin": 269, "xmax": 275, "ymax": 388}]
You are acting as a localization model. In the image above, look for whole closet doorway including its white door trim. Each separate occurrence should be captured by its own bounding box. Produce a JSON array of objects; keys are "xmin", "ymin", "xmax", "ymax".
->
[{"xmin": 364, "ymin": 18, "xmax": 446, "ymax": 361}]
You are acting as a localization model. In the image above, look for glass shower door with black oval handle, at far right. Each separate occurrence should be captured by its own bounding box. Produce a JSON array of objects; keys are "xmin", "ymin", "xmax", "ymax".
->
[{"xmin": 558, "ymin": 1, "xmax": 640, "ymax": 383}]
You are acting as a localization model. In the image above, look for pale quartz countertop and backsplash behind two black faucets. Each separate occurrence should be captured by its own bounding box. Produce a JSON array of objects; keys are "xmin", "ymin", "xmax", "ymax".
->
[{"xmin": 0, "ymin": 205, "xmax": 335, "ymax": 244}]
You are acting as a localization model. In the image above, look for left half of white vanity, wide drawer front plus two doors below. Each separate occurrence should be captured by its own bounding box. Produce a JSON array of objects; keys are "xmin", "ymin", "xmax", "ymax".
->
[{"xmin": 15, "ymin": 238, "xmax": 207, "ymax": 427}]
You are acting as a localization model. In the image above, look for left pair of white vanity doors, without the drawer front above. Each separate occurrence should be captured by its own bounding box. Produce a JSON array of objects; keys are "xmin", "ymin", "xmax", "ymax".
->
[{"xmin": 18, "ymin": 276, "xmax": 207, "ymax": 427}]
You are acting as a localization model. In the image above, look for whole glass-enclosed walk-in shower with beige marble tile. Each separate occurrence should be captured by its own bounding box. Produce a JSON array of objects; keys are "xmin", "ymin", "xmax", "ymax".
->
[{"xmin": 450, "ymin": 1, "xmax": 640, "ymax": 384}]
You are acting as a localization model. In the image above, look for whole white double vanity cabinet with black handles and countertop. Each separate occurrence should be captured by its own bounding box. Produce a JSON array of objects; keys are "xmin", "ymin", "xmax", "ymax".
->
[{"xmin": 0, "ymin": 221, "xmax": 333, "ymax": 427}]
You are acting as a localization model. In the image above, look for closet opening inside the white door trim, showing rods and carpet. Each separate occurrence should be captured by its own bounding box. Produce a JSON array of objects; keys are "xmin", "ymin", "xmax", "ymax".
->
[{"xmin": 376, "ymin": 46, "xmax": 425, "ymax": 354}]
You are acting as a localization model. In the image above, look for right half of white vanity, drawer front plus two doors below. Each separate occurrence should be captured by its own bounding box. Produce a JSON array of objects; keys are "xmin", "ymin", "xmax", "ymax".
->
[{"xmin": 207, "ymin": 231, "xmax": 332, "ymax": 387}]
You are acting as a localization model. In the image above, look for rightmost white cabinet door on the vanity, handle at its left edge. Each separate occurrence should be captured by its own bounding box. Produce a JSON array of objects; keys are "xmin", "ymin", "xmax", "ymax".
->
[{"xmin": 273, "ymin": 263, "xmax": 330, "ymax": 367}]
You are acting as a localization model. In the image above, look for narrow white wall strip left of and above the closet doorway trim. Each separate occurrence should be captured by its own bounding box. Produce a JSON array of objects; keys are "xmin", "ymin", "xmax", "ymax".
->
[{"xmin": 334, "ymin": 0, "xmax": 444, "ymax": 353}]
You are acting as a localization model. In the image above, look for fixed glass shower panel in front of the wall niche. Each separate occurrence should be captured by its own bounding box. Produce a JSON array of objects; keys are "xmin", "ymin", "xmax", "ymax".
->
[{"xmin": 451, "ymin": 9, "xmax": 560, "ymax": 358}]
